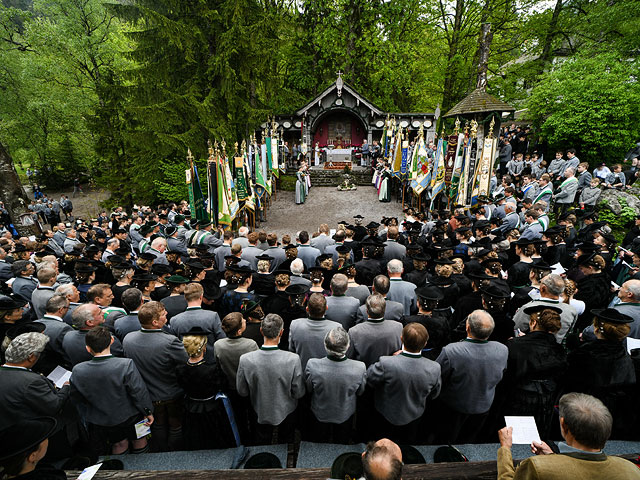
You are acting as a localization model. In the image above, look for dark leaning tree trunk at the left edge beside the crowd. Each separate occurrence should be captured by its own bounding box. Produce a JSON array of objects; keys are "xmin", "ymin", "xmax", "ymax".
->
[{"xmin": 0, "ymin": 143, "xmax": 40, "ymax": 236}]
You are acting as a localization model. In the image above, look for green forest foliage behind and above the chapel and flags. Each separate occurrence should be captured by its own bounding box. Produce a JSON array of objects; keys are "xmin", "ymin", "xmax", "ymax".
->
[{"xmin": 0, "ymin": 0, "xmax": 640, "ymax": 204}]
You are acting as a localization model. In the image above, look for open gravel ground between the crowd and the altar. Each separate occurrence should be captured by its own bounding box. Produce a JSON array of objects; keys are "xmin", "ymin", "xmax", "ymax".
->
[{"xmin": 260, "ymin": 185, "xmax": 402, "ymax": 237}]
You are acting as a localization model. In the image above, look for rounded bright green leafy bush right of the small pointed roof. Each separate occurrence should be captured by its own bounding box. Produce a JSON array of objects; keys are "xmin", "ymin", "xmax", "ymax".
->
[{"xmin": 527, "ymin": 53, "xmax": 640, "ymax": 164}]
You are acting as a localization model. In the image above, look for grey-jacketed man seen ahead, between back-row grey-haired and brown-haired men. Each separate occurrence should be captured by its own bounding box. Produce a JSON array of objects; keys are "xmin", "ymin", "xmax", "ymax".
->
[{"xmin": 349, "ymin": 287, "xmax": 402, "ymax": 367}]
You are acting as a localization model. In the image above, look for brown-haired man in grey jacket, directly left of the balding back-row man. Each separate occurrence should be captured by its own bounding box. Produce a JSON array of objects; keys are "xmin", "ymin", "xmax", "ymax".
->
[{"xmin": 367, "ymin": 322, "xmax": 441, "ymax": 443}]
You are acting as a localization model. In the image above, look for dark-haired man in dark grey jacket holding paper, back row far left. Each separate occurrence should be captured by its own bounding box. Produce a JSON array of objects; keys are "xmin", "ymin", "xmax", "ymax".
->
[{"xmin": 69, "ymin": 326, "xmax": 153, "ymax": 455}]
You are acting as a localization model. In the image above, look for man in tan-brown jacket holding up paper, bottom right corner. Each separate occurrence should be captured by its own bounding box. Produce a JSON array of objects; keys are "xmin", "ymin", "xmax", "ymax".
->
[{"xmin": 498, "ymin": 393, "xmax": 640, "ymax": 480}]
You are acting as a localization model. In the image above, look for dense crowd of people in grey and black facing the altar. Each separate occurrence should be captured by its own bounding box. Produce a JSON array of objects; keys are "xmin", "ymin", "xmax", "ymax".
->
[{"xmin": 0, "ymin": 147, "xmax": 640, "ymax": 478}]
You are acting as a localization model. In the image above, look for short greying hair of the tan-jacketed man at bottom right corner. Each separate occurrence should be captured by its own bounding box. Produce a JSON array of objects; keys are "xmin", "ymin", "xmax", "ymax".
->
[{"xmin": 559, "ymin": 392, "xmax": 613, "ymax": 450}]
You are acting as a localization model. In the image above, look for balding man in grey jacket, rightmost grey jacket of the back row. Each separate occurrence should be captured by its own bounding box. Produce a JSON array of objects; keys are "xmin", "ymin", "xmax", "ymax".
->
[{"xmin": 435, "ymin": 310, "xmax": 509, "ymax": 444}]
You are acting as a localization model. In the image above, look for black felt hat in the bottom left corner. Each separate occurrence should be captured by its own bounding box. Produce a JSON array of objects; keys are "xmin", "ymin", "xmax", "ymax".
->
[{"xmin": 0, "ymin": 417, "xmax": 57, "ymax": 461}]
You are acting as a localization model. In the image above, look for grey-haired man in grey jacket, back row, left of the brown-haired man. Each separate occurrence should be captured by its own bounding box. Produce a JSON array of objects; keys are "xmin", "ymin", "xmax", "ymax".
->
[{"xmin": 304, "ymin": 327, "xmax": 367, "ymax": 443}]
